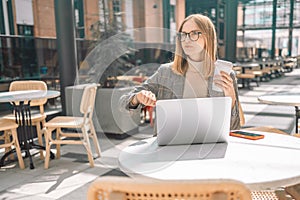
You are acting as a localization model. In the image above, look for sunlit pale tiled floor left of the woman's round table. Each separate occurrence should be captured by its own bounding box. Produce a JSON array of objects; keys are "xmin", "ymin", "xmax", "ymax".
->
[{"xmin": 0, "ymin": 126, "xmax": 152, "ymax": 200}]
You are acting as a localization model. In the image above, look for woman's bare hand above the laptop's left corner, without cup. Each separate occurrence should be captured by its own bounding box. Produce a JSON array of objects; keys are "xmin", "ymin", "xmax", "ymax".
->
[{"xmin": 132, "ymin": 90, "xmax": 156, "ymax": 107}]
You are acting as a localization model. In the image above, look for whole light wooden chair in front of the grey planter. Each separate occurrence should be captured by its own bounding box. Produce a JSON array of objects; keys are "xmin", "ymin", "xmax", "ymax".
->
[{"xmin": 43, "ymin": 84, "xmax": 100, "ymax": 169}]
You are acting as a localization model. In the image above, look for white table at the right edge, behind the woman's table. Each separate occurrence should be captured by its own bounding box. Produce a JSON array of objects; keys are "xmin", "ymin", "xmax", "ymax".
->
[{"xmin": 257, "ymin": 93, "xmax": 300, "ymax": 133}]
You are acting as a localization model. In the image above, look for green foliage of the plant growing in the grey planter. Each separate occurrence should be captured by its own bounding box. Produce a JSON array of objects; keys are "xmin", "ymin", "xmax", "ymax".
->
[{"xmin": 86, "ymin": 11, "xmax": 135, "ymax": 87}]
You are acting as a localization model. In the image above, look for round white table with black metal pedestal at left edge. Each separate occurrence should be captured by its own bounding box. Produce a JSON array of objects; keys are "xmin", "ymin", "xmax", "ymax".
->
[{"xmin": 0, "ymin": 90, "xmax": 60, "ymax": 169}]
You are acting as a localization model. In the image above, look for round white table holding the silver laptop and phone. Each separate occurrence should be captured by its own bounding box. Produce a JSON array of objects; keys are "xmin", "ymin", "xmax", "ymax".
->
[{"xmin": 119, "ymin": 132, "xmax": 300, "ymax": 189}]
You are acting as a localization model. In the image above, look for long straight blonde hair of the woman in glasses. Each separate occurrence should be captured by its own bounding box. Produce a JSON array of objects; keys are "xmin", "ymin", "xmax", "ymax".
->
[{"xmin": 172, "ymin": 14, "xmax": 217, "ymax": 78}]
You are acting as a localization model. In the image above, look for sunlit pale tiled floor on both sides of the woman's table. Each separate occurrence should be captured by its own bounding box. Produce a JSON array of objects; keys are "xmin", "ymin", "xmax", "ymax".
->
[{"xmin": 0, "ymin": 69, "xmax": 300, "ymax": 200}]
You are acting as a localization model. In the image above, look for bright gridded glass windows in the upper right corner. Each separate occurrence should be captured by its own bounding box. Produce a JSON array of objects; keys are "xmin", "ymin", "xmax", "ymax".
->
[{"xmin": 237, "ymin": 0, "xmax": 300, "ymax": 56}]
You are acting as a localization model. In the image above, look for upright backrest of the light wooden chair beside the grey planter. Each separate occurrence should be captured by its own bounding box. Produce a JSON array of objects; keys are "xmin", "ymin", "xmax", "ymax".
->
[{"xmin": 80, "ymin": 83, "xmax": 98, "ymax": 118}]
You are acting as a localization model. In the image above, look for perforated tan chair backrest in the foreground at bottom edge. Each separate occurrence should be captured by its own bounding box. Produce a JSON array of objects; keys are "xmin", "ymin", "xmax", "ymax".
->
[{"xmin": 87, "ymin": 176, "xmax": 251, "ymax": 200}]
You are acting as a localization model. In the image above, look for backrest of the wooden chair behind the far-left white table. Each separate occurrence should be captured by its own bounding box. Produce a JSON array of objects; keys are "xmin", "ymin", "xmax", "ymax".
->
[{"xmin": 9, "ymin": 80, "xmax": 47, "ymax": 109}]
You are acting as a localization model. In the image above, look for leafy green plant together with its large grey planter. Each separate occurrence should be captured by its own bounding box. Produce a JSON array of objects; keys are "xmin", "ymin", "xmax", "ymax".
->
[{"xmin": 66, "ymin": 4, "xmax": 140, "ymax": 137}]
